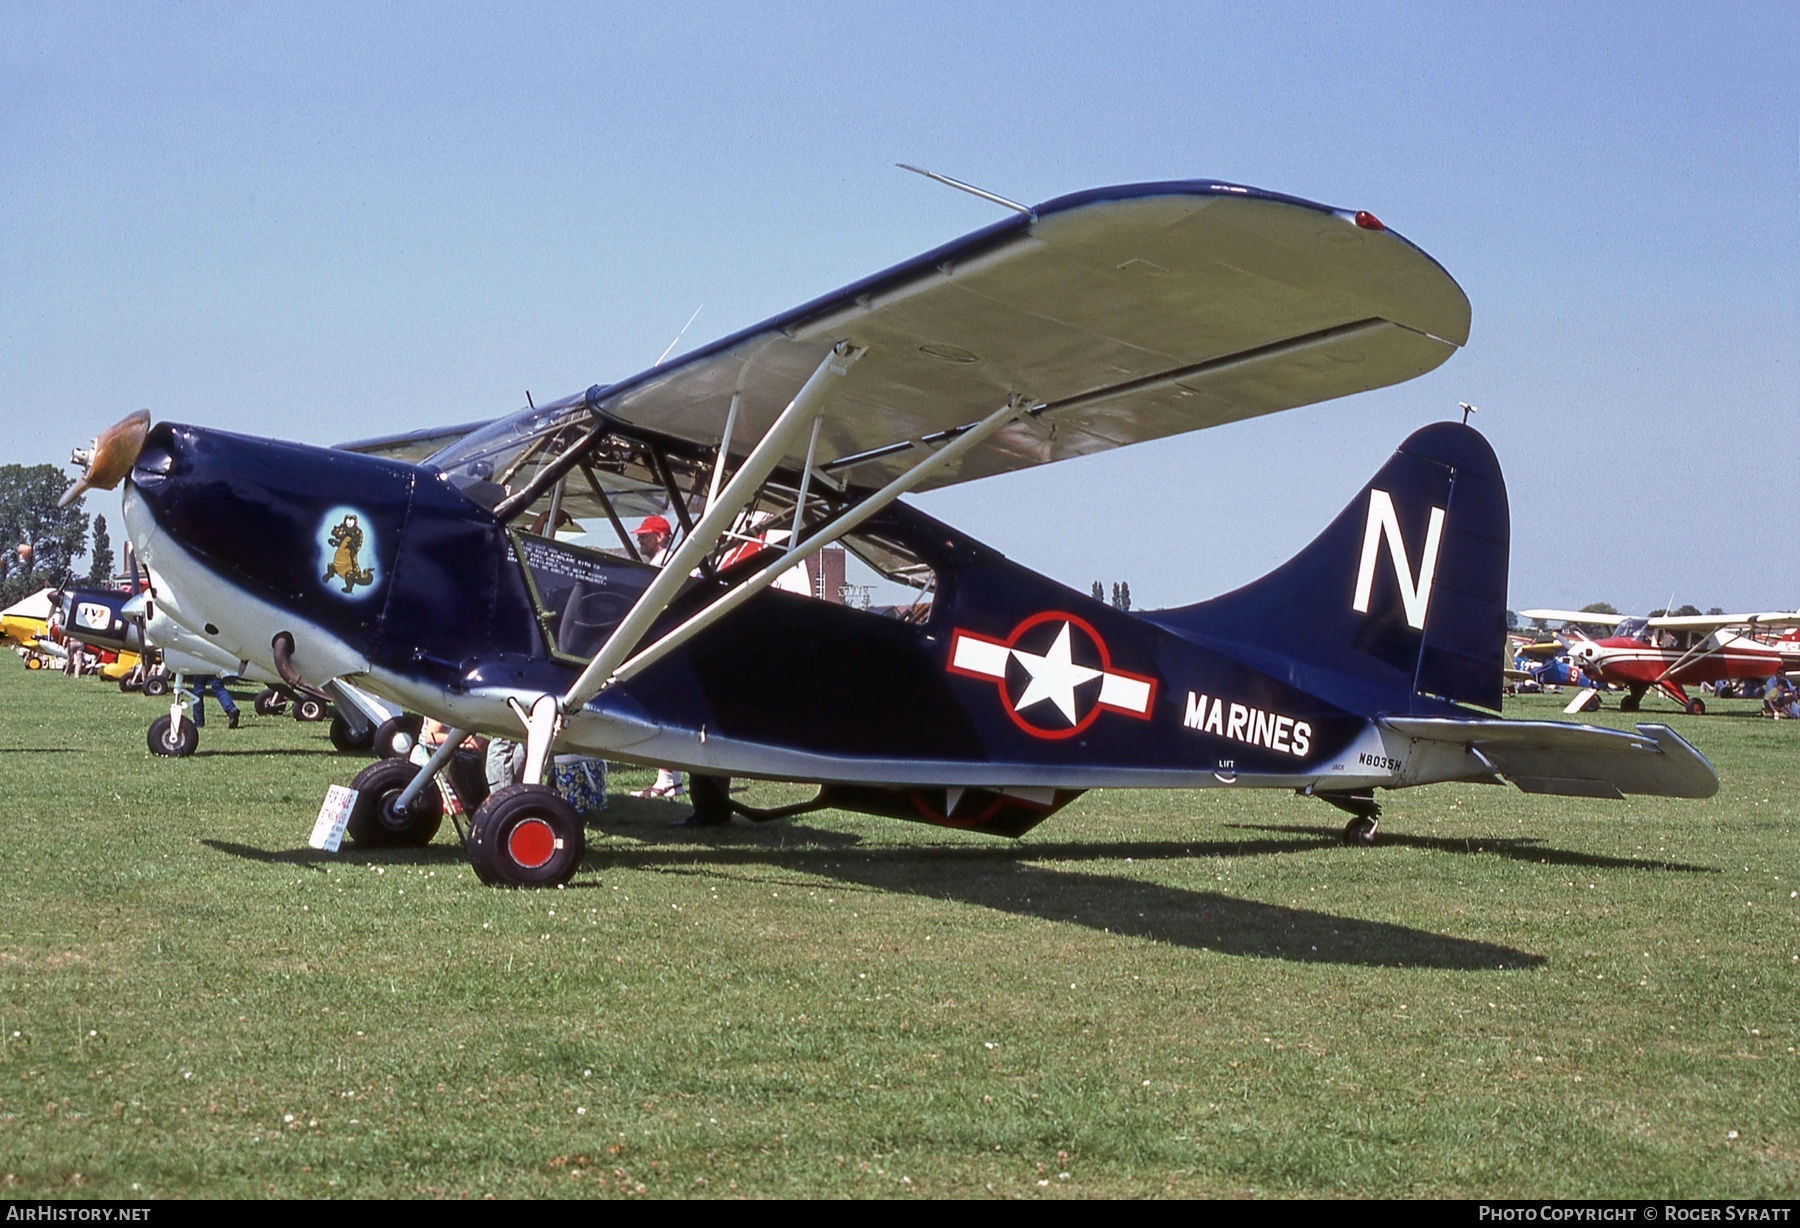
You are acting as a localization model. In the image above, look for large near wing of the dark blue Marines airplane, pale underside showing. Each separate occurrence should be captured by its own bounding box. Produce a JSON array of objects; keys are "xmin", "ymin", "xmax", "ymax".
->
[{"xmin": 589, "ymin": 182, "xmax": 1469, "ymax": 488}]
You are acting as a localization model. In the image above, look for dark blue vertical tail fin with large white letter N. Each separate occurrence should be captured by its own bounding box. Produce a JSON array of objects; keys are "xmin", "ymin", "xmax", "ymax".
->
[{"xmin": 1145, "ymin": 423, "xmax": 1512, "ymax": 713}]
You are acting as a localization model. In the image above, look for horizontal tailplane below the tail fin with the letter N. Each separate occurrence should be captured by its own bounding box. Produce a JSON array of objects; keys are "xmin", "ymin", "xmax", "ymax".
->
[{"xmin": 1381, "ymin": 717, "xmax": 1719, "ymax": 798}]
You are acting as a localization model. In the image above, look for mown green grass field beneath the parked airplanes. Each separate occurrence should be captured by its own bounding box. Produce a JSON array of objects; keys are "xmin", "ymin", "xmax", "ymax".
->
[{"xmin": 0, "ymin": 663, "xmax": 1800, "ymax": 1197}]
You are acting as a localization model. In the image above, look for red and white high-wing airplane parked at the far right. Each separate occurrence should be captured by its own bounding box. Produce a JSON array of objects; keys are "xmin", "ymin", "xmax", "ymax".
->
[{"xmin": 1519, "ymin": 610, "xmax": 1800, "ymax": 717}]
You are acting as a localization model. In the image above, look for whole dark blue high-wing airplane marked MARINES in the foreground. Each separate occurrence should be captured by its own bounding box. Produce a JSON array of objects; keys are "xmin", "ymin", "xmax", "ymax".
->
[{"xmin": 85, "ymin": 182, "xmax": 1717, "ymax": 884}]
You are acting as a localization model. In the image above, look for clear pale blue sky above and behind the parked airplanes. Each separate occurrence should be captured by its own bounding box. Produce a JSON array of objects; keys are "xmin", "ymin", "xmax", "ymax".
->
[{"xmin": 0, "ymin": 0, "xmax": 1800, "ymax": 609}]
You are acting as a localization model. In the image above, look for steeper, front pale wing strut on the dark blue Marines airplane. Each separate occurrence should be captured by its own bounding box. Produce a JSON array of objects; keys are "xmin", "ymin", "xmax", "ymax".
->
[{"xmin": 562, "ymin": 342, "xmax": 864, "ymax": 711}]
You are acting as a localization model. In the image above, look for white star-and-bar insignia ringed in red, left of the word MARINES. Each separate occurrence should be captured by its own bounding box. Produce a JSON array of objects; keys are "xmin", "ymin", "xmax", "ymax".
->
[{"xmin": 949, "ymin": 610, "xmax": 1156, "ymax": 738}]
